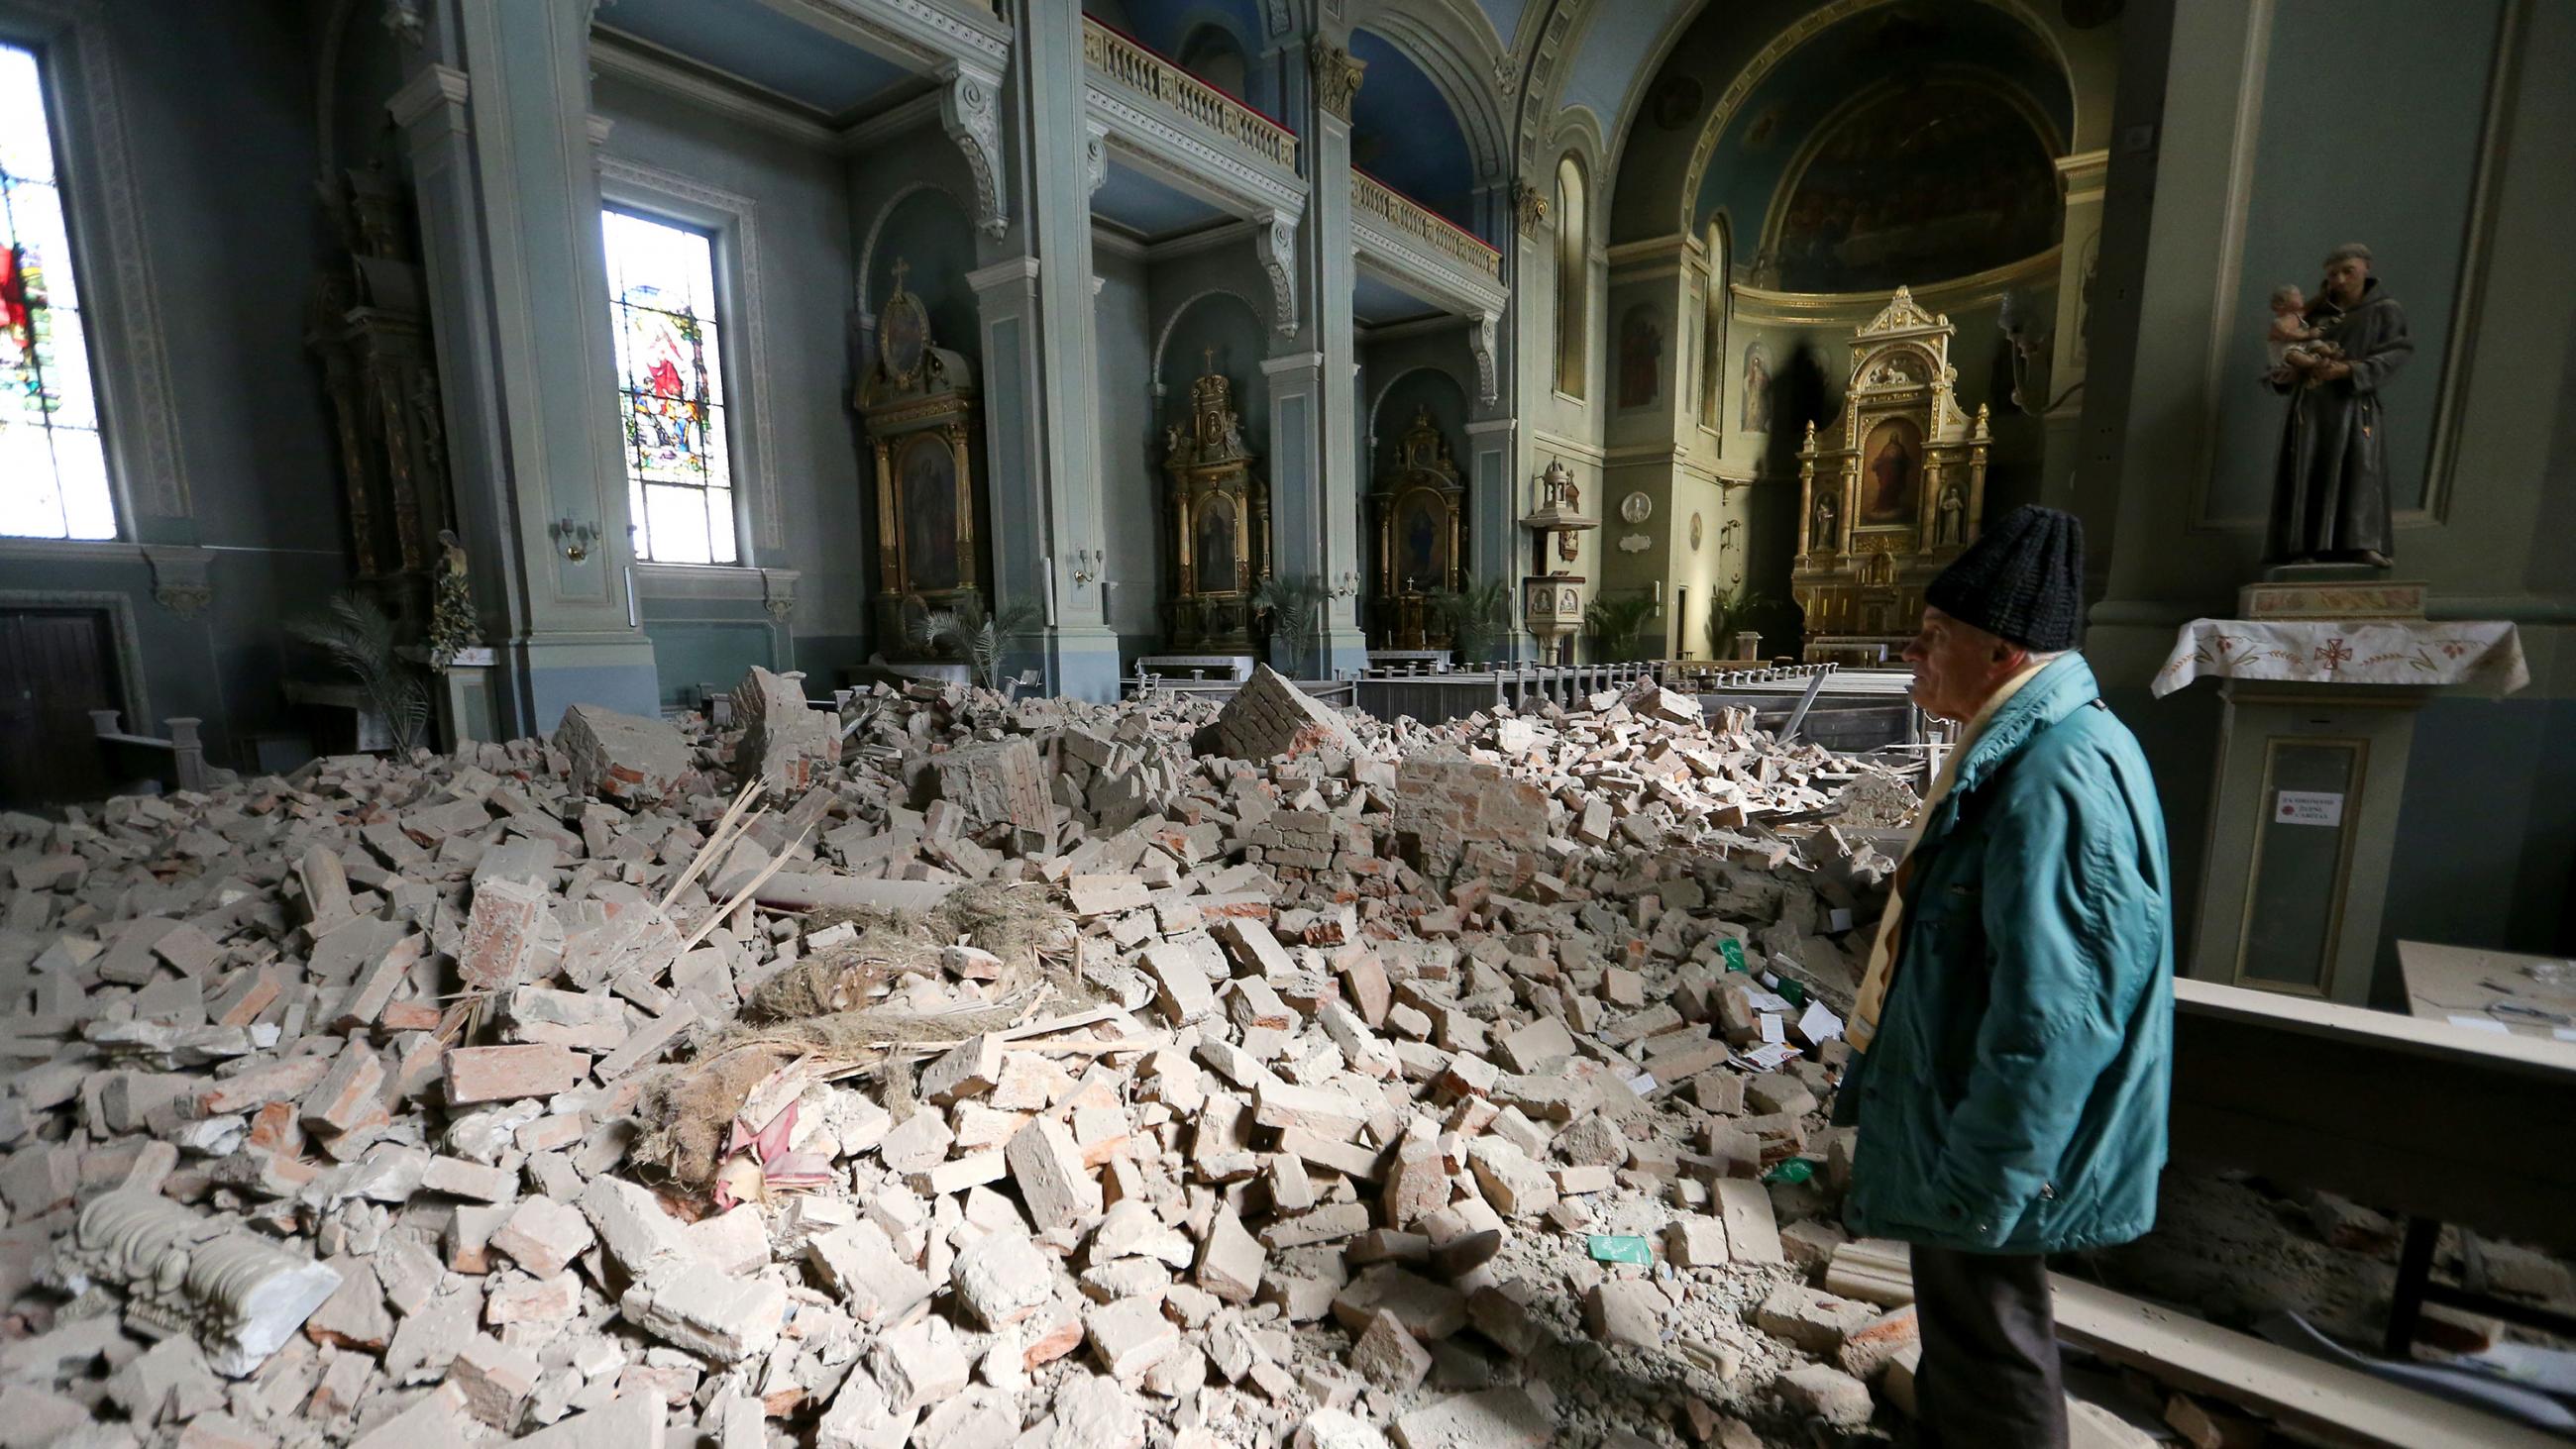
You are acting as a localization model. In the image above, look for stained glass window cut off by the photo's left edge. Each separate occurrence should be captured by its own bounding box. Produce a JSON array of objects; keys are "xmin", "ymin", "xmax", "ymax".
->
[{"xmin": 0, "ymin": 44, "xmax": 116, "ymax": 538}]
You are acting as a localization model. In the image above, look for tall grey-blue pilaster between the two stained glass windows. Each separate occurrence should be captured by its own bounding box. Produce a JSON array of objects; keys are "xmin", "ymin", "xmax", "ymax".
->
[{"xmin": 389, "ymin": 0, "xmax": 660, "ymax": 734}]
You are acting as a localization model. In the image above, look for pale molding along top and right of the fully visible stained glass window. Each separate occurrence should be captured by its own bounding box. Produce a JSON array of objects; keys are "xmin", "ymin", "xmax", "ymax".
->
[{"xmin": 600, "ymin": 157, "xmax": 789, "ymax": 567}]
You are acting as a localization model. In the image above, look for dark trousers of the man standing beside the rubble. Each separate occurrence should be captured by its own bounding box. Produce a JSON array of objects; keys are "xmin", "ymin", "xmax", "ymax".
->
[{"xmin": 1914, "ymin": 1243, "xmax": 2066, "ymax": 1449}]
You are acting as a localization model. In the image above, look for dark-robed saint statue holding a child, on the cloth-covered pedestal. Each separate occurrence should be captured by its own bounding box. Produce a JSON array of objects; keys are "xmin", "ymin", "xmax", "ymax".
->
[{"xmin": 2264, "ymin": 242, "xmax": 2414, "ymax": 569}]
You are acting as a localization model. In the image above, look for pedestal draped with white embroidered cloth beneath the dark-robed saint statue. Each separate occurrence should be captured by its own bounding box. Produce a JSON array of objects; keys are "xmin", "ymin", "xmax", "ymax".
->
[{"xmin": 2154, "ymin": 615, "xmax": 2529, "ymax": 1006}]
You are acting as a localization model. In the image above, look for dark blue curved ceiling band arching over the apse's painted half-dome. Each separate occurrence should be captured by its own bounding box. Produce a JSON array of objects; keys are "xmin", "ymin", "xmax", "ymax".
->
[{"xmin": 1677, "ymin": 0, "xmax": 2074, "ymax": 262}]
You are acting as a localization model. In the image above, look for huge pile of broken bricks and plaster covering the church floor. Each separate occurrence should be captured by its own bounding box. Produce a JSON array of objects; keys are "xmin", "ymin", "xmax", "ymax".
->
[{"xmin": 0, "ymin": 672, "xmax": 1911, "ymax": 1449}]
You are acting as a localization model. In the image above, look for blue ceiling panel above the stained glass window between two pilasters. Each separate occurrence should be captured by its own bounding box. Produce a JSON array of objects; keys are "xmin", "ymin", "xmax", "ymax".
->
[{"xmin": 600, "ymin": 0, "xmax": 917, "ymax": 121}]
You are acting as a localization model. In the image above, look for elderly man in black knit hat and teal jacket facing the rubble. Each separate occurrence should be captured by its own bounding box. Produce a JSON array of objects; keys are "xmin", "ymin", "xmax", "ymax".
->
[{"xmin": 1834, "ymin": 507, "xmax": 2174, "ymax": 1449}]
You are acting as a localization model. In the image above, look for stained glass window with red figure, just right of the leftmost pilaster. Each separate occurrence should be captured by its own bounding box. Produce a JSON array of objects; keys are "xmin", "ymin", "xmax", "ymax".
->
[{"xmin": 602, "ymin": 211, "xmax": 739, "ymax": 564}]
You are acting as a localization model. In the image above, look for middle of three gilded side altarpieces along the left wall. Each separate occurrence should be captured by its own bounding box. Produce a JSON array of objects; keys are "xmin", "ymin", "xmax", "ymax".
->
[{"xmin": 1162, "ymin": 353, "xmax": 1270, "ymax": 654}]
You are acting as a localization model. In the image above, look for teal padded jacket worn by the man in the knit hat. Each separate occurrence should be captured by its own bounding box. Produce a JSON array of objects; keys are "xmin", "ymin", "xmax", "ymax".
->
[{"xmin": 1834, "ymin": 654, "xmax": 2174, "ymax": 1254}]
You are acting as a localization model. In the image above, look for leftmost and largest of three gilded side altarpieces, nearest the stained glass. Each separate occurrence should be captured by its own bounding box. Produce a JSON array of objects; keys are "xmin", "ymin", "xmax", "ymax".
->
[{"xmin": 858, "ymin": 259, "xmax": 984, "ymax": 659}]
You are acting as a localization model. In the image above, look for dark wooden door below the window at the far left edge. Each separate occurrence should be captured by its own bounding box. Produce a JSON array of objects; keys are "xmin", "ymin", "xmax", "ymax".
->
[{"xmin": 0, "ymin": 610, "xmax": 121, "ymax": 805}]
